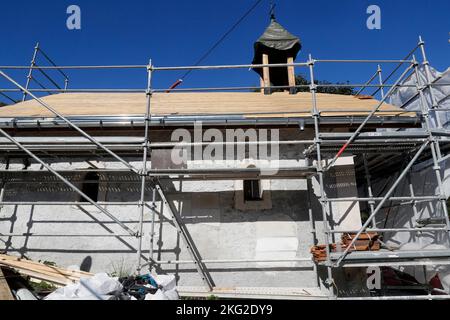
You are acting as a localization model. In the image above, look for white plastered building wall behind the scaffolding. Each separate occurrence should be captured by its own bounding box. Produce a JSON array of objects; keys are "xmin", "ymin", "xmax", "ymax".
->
[{"xmin": 0, "ymin": 131, "xmax": 360, "ymax": 287}]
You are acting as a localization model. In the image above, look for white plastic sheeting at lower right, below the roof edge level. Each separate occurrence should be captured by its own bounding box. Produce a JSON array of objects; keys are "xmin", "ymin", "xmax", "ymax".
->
[{"xmin": 373, "ymin": 150, "xmax": 450, "ymax": 293}]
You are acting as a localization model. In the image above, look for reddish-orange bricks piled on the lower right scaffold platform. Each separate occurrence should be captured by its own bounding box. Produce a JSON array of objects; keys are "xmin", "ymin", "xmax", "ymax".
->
[{"xmin": 311, "ymin": 232, "xmax": 380, "ymax": 262}]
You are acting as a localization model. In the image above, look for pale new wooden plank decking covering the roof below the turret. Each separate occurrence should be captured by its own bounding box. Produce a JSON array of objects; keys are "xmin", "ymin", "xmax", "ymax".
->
[{"xmin": 0, "ymin": 92, "xmax": 415, "ymax": 118}]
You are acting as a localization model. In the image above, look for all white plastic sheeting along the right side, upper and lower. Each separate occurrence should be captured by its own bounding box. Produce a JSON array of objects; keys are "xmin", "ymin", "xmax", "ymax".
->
[{"xmin": 373, "ymin": 65, "xmax": 450, "ymax": 293}]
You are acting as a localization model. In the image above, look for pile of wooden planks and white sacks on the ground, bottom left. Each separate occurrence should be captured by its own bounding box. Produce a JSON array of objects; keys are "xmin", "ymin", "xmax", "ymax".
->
[{"xmin": 0, "ymin": 255, "xmax": 179, "ymax": 300}]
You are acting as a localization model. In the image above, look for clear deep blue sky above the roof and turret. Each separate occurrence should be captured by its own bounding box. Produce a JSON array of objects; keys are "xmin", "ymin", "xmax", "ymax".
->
[{"xmin": 0, "ymin": 0, "xmax": 450, "ymax": 101}]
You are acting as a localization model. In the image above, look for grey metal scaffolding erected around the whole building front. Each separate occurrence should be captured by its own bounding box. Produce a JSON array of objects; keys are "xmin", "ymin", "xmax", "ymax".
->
[{"xmin": 0, "ymin": 39, "xmax": 450, "ymax": 299}]
